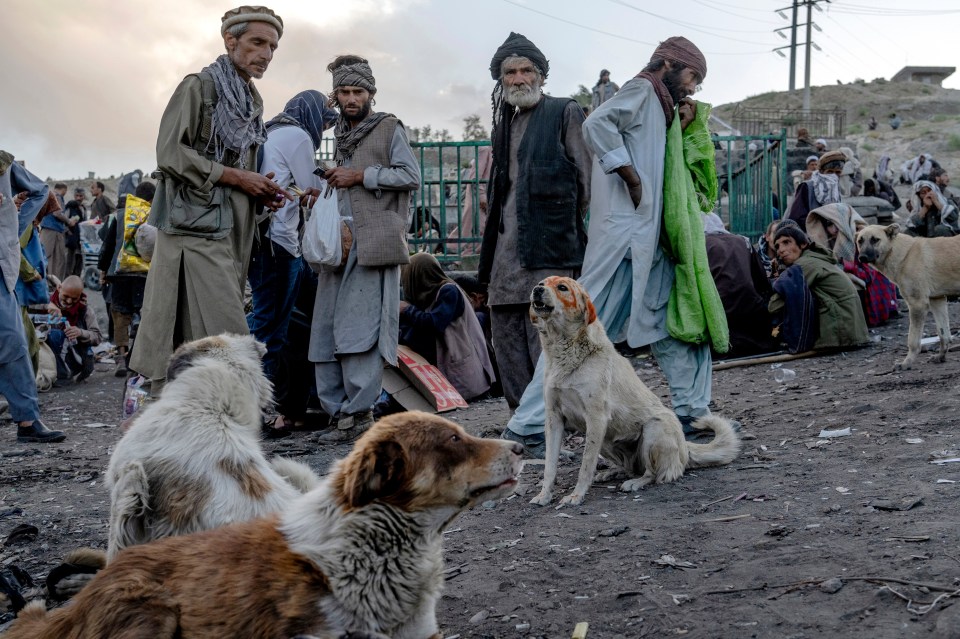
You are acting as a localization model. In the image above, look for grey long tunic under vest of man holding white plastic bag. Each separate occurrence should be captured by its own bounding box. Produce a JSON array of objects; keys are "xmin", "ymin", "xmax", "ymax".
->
[{"xmin": 309, "ymin": 125, "xmax": 420, "ymax": 365}]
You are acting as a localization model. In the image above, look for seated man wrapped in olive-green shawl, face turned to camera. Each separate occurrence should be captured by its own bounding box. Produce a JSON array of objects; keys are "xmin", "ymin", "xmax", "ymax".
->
[{"xmin": 768, "ymin": 225, "xmax": 870, "ymax": 350}]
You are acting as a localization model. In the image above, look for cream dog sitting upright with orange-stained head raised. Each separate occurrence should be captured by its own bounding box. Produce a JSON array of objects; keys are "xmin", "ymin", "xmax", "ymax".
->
[{"xmin": 530, "ymin": 277, "xmax": 740, "ymax": 506}]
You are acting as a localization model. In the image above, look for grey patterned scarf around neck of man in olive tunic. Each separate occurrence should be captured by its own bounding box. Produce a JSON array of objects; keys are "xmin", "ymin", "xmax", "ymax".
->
[{"xmin": 204, "ymin": 53, "xmax": 267, "ymax": 168}]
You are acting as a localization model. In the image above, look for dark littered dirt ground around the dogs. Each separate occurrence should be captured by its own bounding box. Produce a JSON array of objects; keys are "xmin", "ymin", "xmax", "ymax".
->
[{"xmin": 0, "ymin": 303, "xmax": 960, "ymax": 639}]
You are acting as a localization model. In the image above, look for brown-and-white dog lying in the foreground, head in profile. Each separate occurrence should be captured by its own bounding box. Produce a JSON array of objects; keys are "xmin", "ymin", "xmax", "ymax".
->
[{"xmin": 6, "ymin": 416, "xmax": 523, "ymax": 639}]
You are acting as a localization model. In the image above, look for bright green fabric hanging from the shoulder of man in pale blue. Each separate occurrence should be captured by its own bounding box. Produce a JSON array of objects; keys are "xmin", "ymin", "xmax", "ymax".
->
[{"xmin": 663, "ymin": 102, "xmax": 730, "ymax": 353}]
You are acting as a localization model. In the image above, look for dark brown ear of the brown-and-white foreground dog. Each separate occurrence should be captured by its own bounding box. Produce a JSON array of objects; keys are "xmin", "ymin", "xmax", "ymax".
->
[{"xmin": 341, "ymin": 439, "xmax": 407, "ymax": 508}]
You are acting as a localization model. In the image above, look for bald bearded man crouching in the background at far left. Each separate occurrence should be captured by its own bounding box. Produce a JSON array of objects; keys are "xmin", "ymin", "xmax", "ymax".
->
[{"xmin": 47, "ymin": 275, "xmax": 103, "ymax": 386}]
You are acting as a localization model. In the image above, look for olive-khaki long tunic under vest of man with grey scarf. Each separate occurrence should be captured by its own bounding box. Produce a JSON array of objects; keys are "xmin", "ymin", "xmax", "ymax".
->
[{"xmin": 130, "ymin": 75, "xmax": 263, "ymax": 379}]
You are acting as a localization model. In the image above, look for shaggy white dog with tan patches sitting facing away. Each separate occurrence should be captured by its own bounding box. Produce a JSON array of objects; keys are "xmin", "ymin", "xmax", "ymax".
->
[{"xmin": 107, "ymin": 334, "xmax": 319, "ymax": 559}]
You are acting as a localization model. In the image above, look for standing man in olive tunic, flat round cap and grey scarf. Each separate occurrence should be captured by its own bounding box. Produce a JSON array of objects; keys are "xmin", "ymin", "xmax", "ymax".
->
[{"xmin": 130, "ymin": 6, "xmax": 292, "ymax": 384}]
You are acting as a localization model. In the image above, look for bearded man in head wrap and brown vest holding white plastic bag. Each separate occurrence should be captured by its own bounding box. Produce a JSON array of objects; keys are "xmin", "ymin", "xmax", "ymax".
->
[{"xmin": 309, "ymin": 55, "xmax": 420, "ymax": 443}]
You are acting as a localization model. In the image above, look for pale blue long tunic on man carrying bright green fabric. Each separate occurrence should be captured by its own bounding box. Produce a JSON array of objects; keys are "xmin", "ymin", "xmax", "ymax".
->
[{"xmin": 580, "ymin": 78, "xmax": 674, "ymax": 348}]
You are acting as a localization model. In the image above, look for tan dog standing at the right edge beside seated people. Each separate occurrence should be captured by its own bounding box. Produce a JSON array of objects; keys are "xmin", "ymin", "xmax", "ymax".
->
[{"xmin": 857, "ymin": 224, "xmax": 960, "ymax": 370}]
